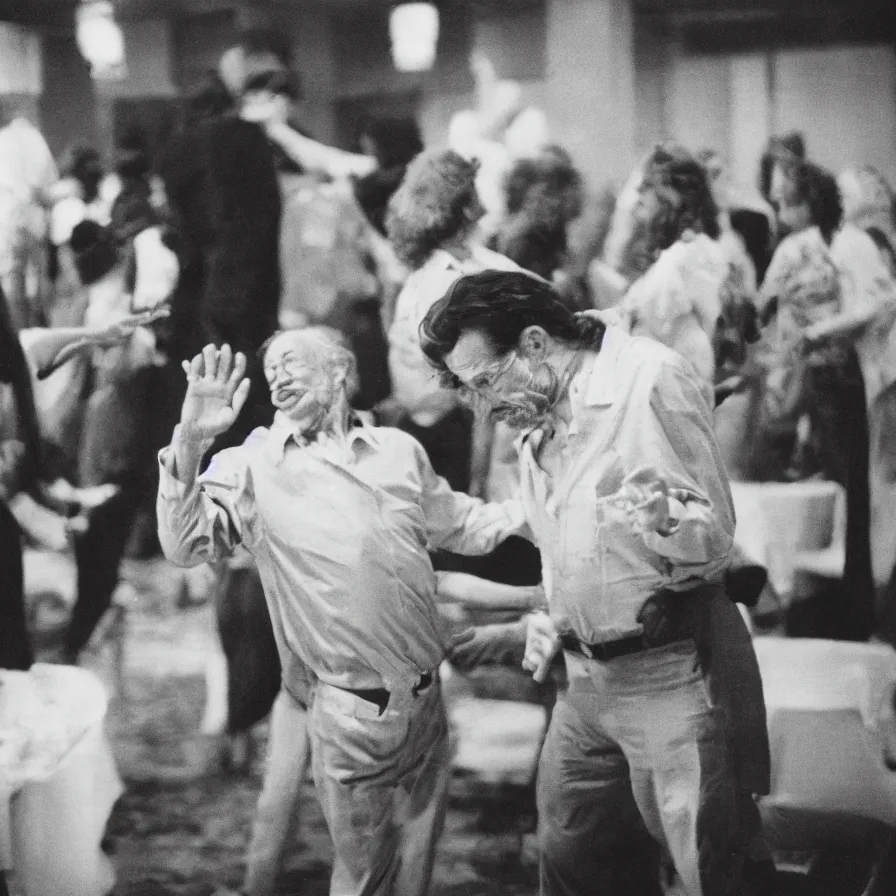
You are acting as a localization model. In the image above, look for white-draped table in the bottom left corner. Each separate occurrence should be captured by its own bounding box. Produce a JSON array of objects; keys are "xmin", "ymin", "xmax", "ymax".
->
[{"xmin": 0, "ymin": 664, "xmax": 123, "ymax": 896}]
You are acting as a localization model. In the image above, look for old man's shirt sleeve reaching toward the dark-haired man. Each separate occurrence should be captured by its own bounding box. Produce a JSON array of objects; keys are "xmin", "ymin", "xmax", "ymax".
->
[{"xmin": 417, "ymin": 446, "xmax": 528, "ymax": 555}]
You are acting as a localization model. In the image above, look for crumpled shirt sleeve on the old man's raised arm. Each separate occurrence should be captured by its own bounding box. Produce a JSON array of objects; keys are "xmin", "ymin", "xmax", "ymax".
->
[{"xmin": 156, "ymin": 446, "xmax": 253, "ymax": 566}]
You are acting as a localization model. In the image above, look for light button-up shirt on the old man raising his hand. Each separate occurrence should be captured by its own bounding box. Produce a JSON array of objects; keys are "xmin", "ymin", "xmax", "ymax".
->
[{"xmin": 157, "ymin": 415, "xmax": 525, "ymax": 692}]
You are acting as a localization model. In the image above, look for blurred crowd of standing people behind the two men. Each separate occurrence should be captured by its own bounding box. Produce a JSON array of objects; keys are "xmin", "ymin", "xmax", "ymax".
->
[{"xmin": 0, "ymin": 22, "xmax": 896, "ymax": 896}]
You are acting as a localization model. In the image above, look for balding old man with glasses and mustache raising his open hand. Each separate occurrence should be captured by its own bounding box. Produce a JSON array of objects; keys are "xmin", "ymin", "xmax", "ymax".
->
[{"xmin": 158, "ymin": 329, "xmax": 524, "ymax": 896}]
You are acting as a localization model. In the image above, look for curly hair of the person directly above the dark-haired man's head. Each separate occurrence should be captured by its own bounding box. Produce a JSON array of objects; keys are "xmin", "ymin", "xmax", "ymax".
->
[{"xmin": 386, "ymin": 149, "xmax": 481, "ymax": 270}]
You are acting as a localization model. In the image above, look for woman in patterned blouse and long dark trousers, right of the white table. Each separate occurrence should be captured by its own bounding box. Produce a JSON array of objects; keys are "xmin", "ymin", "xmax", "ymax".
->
[{"xmin": 760, "ymin": 161, "xmax": 874, "ymax": 641}]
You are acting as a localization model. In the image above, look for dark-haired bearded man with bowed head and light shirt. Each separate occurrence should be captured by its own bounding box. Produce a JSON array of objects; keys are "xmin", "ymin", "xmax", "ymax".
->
[{"xmin": 421, "ymin": 271, "xmax": 769, "ymax": 896}]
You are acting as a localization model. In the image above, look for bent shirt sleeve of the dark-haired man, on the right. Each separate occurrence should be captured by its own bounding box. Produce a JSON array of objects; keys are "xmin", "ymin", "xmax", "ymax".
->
[{"xmin": 643, "ymin": 364, "xmax": 735, "ymax": 580}]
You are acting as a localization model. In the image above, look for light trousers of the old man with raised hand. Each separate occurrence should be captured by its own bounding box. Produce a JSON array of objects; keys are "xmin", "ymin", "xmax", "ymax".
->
[{"xmin": 311, "ymin": 681, "xmax": 450, "ymax": 896}]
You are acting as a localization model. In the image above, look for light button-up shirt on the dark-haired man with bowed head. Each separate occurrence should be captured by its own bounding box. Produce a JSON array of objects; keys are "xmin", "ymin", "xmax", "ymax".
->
[{"xmin": 520, "ymin": 327, "xmax": 734, "ymax": 644}]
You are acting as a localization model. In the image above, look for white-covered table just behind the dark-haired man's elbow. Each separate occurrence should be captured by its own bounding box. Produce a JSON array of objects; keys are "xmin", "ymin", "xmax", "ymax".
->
[{"xmin": 731, "ymin": 480, "xmax": 845, "ymax": 599}]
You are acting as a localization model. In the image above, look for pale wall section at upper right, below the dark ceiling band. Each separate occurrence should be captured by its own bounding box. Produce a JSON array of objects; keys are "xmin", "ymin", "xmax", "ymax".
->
[{"xmin": 660, "ymin": 45, "xmax": 896, "ymax": 192}]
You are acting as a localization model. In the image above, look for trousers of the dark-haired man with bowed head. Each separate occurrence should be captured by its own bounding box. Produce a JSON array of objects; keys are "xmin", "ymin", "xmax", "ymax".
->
[{"xmin": 538, "ymin": 640, "xmax": 755, "ymax": 896}]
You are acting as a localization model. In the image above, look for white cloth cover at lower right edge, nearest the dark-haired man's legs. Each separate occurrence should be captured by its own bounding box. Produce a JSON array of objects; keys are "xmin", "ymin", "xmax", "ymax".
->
[{"xmin": 753, "ymin": 637, "xmax": 896, "ymax": 825}]
